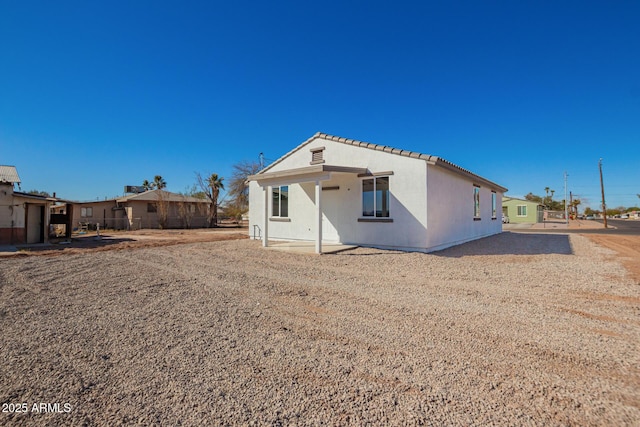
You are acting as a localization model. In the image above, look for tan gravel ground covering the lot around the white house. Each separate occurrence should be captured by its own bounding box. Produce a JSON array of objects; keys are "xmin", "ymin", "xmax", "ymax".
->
[{"xmin": 0, "ymin": 233, "xmax": 640, "ymax": 426}]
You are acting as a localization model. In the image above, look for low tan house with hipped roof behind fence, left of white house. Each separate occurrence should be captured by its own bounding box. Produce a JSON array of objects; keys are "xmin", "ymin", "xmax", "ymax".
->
[{"xmin": 58, "ymin": 190, "xmax": 209, "ymax": 230}]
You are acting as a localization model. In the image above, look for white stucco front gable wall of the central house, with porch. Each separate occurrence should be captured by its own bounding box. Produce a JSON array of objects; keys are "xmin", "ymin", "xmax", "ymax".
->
[{"xmin": 249, "ymin": 138, "xmax": 427, "ymax": 250}]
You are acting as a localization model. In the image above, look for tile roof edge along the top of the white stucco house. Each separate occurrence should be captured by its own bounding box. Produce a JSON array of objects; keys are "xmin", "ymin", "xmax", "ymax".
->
[{"xmin": 259, "ymin": 132, "xmax": 507, "ymax": 192}]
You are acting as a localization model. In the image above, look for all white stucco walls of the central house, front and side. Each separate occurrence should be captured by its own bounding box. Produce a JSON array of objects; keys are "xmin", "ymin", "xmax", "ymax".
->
[{"xmin": 249, "ymin": 137, "xmax": 502, "ymax": 252}]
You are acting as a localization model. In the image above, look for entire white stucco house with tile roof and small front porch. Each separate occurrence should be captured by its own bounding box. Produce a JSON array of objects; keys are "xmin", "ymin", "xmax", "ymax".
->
[{"xmin": 249, "ymin": 133, "xmax": 507, "ymax": 253}]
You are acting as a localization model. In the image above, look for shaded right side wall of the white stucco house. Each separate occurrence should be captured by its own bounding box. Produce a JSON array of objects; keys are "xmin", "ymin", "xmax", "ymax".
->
[{"xmin": 427, "ymin": 166, "xmax": 502, "ymax": 250}]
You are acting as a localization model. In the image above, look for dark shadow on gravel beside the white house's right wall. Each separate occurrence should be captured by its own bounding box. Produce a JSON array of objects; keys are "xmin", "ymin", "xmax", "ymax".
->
[{"xmin": 432, "ymin": 231, "xmax": 573, "ymax": 258}]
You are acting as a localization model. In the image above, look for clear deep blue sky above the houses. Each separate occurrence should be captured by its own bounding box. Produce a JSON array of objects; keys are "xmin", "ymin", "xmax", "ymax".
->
[{"xmin": 0, "ymin": 0, "xmax": 640, "ymax": 208}]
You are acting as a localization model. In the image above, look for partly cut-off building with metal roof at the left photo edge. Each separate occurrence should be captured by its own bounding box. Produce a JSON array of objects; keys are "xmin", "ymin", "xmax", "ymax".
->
[{"xmin": 0, "ymin": 166, "xmax": 55, "ymax": 245}]
